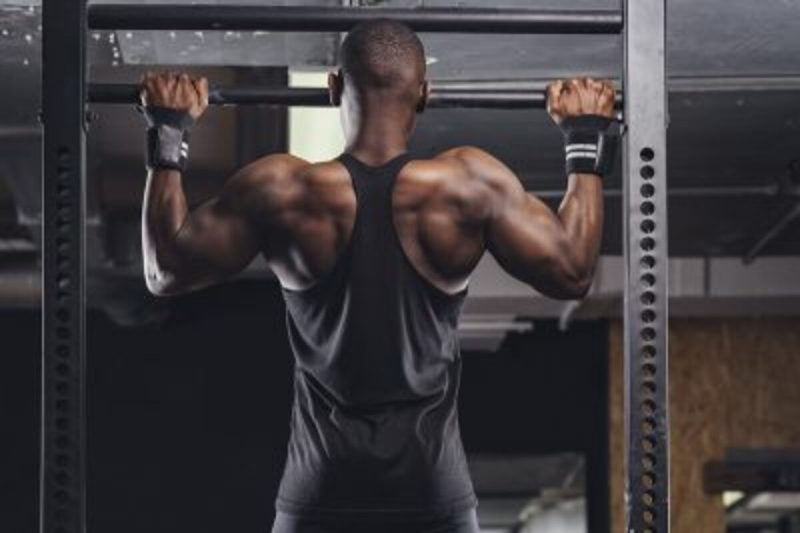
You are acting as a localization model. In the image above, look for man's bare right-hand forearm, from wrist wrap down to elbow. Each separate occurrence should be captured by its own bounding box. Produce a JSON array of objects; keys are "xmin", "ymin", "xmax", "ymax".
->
[{"xmin": 558, "ymin": 174, "xmax": 603, "ymax": 291}]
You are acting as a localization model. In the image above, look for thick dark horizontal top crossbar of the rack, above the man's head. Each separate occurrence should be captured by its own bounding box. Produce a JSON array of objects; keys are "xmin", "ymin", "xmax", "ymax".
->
[{"xmin": 88, "ymin": 4, "xmax": 623, "ymax": 34}]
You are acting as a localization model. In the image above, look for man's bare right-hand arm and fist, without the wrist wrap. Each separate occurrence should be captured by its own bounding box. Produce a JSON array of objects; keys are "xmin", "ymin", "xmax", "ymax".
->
[{"xmin": 460, "ymin": 80, "xmax": 614, "ymax": 299}]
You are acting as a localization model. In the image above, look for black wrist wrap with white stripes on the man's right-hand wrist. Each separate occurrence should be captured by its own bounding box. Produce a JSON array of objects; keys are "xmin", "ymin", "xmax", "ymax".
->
[{"xmin": 560, "ymin": 115, "xmax": 619, "ymax": 177}]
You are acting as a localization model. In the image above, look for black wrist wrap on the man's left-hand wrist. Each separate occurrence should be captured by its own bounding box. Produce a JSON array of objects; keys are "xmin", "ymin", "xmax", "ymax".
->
[{"xmin": 139, "ymin": 107, "xmax": 194, "ymax": 172}]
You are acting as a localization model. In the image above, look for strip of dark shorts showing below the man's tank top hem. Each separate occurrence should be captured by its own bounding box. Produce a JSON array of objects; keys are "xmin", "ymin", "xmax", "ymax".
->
[{"xmin": 272, "ymin": 509, "xmax": 480, "ymax": 533}]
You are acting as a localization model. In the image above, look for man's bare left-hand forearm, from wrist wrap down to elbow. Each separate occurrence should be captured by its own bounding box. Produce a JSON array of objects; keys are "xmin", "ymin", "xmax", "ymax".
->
[{"xmin": 142, "ymin": 170, "xmax": 188, "ymax": 293}]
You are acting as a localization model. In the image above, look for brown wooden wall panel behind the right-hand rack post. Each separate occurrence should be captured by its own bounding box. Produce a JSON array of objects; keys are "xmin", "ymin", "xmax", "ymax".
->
[{"xmin": 609, "ymin": 318, "xmax": 800, "ymax": 533}]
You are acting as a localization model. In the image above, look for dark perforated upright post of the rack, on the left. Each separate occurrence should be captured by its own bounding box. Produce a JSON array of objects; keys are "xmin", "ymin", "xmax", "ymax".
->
[{"xmin": 38, "ymin": 0, "xmax": 89, "ymax": 533}]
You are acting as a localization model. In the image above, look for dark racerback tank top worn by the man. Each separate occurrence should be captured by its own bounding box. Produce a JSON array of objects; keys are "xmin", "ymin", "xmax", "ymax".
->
[{"xmin": 276, "ymin": 154, "xmax": 476, "ymax": 518}]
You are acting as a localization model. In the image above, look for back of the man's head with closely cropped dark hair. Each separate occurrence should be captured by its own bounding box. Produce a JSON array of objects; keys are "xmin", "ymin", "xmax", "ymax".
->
[{"xmin": 339, "ymin": 19, "xmax": 425, "ymax": 93}]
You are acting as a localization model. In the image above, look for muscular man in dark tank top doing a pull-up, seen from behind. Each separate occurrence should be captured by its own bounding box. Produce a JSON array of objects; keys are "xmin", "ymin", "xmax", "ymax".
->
[{"xmin": 142, "ymin": 20, "xmax": 614, "ymax": 533}]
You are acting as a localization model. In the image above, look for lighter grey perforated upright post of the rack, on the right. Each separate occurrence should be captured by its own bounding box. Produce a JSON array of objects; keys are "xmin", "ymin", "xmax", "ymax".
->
[{"xmin": 620, "ymin": 0, "xmax": 670, "ymax": 533}]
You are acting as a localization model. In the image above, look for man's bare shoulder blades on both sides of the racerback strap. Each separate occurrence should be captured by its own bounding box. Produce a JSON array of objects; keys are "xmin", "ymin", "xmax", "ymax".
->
[{"xmin": 265, "ymin": 151, "xmax": 486, "ymax": 292}]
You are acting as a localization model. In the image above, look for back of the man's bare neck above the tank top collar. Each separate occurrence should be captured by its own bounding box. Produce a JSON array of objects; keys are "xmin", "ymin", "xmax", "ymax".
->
[{"xmin": 345, "ymin": 100, "xmax": 414, "ymax": 166}]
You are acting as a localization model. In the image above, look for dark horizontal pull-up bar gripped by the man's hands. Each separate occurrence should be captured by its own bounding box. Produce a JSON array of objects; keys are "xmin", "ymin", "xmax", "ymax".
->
[{"xmin": 89, "ymin": 83, "xmax": 547, "ymax": 109}]
